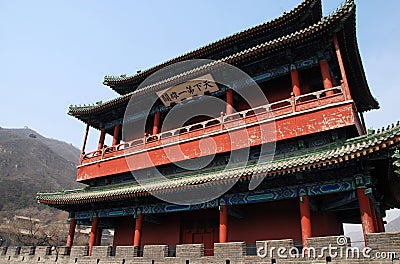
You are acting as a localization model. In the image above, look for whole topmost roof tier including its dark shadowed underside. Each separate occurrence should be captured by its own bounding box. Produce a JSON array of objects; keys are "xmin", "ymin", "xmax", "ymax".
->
[{"xmin": 104, "ymin": 0, "xmax": 322, "ymax": 95}]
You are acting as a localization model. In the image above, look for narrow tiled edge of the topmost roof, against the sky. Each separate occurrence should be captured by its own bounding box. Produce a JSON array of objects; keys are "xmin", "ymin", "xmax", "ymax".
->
[{"xmin": 104, "ymin": 0, "xmax": 322, "ymax": 92}]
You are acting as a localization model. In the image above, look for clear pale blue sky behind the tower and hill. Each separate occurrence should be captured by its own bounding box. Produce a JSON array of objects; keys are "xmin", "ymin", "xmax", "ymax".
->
[{"xmin": 0, "ymin": 0, "xmax": 400, "ymax": 150}]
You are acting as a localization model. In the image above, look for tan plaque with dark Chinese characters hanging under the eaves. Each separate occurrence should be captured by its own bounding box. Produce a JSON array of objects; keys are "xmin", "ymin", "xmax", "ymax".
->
[{"xmin": 157, "ymin": 74, "xmax": 219, "ymax": 106}]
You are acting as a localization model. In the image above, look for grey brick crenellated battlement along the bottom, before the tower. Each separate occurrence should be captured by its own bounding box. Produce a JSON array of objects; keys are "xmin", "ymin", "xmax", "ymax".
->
[{"xmin": 0, "ymin": 232, "xmax": 400, "ymax": 264}]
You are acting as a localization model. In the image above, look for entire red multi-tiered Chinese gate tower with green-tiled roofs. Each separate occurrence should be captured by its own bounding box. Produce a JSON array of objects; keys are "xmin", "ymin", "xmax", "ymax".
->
[{"xmin": 37, "ymin": 0, "xmax": 400, "ymax": 255}]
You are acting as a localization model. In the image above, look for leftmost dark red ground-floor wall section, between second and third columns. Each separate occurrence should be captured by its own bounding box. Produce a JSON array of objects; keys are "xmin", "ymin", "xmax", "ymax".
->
[{"xmin": 113, "ymin": 216, "xmax": 135, "ymax": 247}]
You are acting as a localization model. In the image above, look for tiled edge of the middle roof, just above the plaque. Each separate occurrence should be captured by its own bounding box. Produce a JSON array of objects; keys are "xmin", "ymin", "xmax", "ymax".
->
[{"xmin": 69, "ymin": 0, "xmax": 355, "ymax": 118}]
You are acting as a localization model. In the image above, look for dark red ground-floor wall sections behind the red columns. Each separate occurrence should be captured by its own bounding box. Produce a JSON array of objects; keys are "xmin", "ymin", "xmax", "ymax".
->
[{"xmin": 114, "ymin": 199, "xmax": 341, "ymax": 246}]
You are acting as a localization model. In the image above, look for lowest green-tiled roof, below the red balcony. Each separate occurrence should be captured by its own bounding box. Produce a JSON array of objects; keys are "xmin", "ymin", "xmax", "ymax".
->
[{"xmin": 37, "ymin": 120, "xmax": 400, "ymax": 204}]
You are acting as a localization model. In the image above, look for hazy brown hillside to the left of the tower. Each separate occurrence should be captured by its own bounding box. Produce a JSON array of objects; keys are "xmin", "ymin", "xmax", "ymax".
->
[{"xmin": 0, "ymin": 128, "xmax": 82, "ymax": 211}]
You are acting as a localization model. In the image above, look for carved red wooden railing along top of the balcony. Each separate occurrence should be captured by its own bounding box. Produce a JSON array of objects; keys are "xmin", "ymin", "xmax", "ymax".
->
[{"xmin": 80, "ymin": 86, "xmax": 346, "ymax": 165}]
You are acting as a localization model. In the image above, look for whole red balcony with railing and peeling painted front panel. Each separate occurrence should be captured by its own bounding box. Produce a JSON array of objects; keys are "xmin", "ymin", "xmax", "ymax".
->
[{"xmin": 78, "ymin": 86, "xmax": 362, "ymax": 181}]
